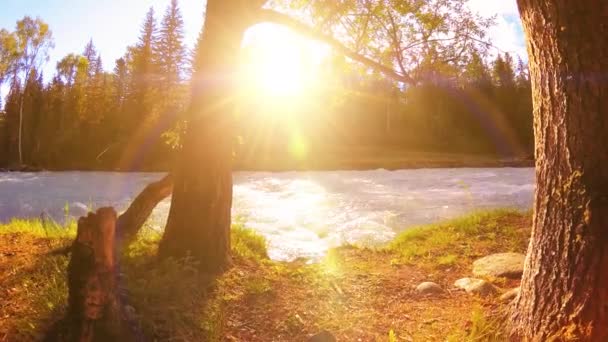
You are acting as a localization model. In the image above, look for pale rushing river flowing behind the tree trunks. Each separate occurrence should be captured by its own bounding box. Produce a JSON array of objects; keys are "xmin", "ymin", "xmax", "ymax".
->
[{"xmin": 0, "ymin": 168, "xmax": 534, "ymax": 260}]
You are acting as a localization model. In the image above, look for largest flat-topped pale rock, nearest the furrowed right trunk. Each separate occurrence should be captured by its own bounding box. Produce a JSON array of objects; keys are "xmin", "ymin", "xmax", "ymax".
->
[{"xmin": 473, "ymin": 253, "xmax": 526, "ymax": 278}]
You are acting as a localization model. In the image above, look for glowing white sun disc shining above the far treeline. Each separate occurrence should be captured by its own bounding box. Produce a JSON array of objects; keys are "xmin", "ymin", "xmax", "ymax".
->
[{"xmin": 241, "ymin": 25, "xmax": 326, "ymax": 101}]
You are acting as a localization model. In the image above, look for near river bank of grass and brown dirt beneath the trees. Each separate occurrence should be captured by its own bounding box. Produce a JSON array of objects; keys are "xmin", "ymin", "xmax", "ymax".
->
[{"xmin": 0, "ymin": 210, "xmax": 531, "ymax": 341}]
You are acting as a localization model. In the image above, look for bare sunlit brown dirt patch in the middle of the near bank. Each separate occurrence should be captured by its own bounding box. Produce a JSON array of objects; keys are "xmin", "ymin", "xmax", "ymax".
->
[{"xmin": 222, "ymin": 248, "xmax": 488, "ymax": 341}]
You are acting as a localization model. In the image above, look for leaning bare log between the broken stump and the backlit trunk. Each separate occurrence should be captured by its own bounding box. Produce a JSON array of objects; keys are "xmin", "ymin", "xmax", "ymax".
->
[{"xmin": 117, "ymin": 174, "xmax": 173, "ymax": 249}]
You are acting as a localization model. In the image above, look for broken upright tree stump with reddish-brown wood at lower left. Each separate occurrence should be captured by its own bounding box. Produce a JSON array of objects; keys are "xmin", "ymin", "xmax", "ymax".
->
[{"xmin": 46, "ymin": 208, "xmax": 137, "ymax": 342}]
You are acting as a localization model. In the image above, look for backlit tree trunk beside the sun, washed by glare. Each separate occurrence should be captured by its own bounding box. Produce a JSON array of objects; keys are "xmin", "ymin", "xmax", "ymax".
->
[{"xmin": 159, "ymin": 0, "xmax": 252, "ymax": 273}]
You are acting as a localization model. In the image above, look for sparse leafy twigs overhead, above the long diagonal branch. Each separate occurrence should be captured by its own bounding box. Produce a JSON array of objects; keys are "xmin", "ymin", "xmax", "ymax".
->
[{"xmin": 274, "ymin": 0, "xmax": 494, "ymax": 81}]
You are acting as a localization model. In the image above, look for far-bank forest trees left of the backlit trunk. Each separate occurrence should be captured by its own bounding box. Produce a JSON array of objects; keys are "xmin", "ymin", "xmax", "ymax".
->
[{"xmin": 0, "ymin": 1, "xmax": 188, "ymax": 169}]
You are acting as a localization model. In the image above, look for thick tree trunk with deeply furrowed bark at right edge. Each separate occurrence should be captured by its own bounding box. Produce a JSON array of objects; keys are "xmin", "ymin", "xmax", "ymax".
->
[{"xmin": 513, "ymin": 0, "xmax": 608, "ymax": 341}]
